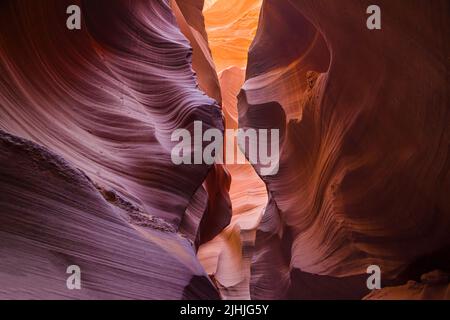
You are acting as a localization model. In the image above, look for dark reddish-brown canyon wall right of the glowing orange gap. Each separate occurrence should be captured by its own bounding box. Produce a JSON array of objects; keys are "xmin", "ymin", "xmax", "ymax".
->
[{"xmin": 239, "ymin": 0, "xmax": 450, "ymax": 298}]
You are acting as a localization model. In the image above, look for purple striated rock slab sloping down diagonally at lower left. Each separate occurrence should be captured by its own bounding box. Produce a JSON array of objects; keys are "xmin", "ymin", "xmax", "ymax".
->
[{"xmin": 0, "ymin": 131, "xmax": 219, "ymax": 299}]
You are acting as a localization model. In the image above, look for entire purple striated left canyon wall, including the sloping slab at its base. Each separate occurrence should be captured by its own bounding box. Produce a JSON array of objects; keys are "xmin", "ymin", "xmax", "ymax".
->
[{"xmin": 0, "ymin": 0, "xmax": 223, "ymax": 299}]
